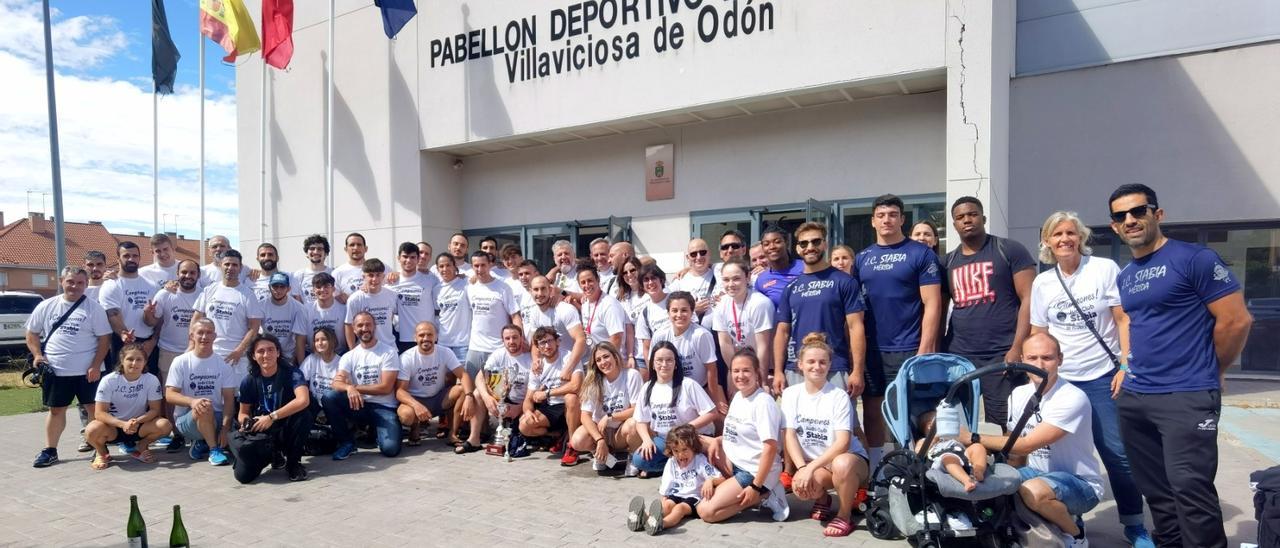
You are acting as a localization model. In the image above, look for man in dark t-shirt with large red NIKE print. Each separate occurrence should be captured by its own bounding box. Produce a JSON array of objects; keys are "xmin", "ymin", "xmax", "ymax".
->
[{"xmin": 942, "ymin": 196, "xmax": 1036, "ymax": 429}]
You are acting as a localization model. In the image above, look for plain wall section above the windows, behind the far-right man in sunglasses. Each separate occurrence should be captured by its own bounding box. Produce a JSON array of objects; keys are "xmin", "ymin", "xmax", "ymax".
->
[{"xmin": 1009, "ymin": 42, "xmax": 1280, "ymax": 245}]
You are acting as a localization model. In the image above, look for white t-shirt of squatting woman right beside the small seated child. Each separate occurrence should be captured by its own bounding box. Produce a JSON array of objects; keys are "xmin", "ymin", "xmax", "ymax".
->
[{"xmin": 721, "ymin": 389, "xmax": 782, "ymax": 476}]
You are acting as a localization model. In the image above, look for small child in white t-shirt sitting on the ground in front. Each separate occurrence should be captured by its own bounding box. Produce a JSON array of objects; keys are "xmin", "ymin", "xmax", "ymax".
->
[{"xmin": 627, "ymin": 424, "xmax": 724, "ymax": 535}]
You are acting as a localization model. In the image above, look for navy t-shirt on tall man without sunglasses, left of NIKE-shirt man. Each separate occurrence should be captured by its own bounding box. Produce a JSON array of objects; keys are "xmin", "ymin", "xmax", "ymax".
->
[{"xmin": 854, "ymin": 239, "xmax": 942, "ymax": 352}]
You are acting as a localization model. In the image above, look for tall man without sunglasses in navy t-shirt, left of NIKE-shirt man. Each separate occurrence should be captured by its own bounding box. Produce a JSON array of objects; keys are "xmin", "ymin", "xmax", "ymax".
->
[{"xmin": 854, "ymin": 195, "xmax": 942, "ymax": 469}]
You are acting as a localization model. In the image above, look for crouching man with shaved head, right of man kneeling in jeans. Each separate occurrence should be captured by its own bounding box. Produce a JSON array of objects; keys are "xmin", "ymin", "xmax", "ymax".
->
[{"xmin": 396, "ymin": 321, "xmax": 475, "ymax": 446}]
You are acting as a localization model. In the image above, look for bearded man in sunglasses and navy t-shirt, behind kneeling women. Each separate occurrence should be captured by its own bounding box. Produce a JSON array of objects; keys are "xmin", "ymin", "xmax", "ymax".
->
[{"xmin": 773, "ymin": 223, "xmax": 867, "ymax": 397}]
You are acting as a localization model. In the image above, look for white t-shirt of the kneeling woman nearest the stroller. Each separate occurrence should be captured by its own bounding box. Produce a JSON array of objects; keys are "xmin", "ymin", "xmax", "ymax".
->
[{"xmin": 782, "ymin": 383, "xmax": 867, "ymax": 461}]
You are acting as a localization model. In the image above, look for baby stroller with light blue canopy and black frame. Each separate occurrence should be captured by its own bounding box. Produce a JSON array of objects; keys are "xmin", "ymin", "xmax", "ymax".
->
[{"xmin": 867, "ymin": 353, "xmax": 1044, "ymax": 548}]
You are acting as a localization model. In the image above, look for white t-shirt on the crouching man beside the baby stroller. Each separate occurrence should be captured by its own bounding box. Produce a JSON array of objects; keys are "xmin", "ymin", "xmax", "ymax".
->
[{"xmin": 1006, "ymin": 379, "xmax": 1103, "ymax": 498}]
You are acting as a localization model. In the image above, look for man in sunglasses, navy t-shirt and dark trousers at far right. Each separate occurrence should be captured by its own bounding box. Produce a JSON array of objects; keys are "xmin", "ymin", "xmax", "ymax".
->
[{"xmin": 1110, "ymin": 184, "xmax": 1253, "ymax": 547}]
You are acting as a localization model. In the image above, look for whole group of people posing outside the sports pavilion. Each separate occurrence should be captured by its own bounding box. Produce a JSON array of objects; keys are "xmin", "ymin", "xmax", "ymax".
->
[{"xmin": 27, "ymin": 184, "xmax": 1251, "ymax": 547}]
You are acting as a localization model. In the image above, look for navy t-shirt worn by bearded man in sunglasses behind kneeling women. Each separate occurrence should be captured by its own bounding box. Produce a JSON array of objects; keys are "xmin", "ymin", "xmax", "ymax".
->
[{"xmin": 777, "ymin": 266, "xmax": 864, "ymax": 371}]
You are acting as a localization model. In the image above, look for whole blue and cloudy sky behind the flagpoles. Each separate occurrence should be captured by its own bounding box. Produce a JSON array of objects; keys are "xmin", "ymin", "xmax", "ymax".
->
[{"xmin": 0, "ymin": 0, "xmax": 241, "ymax": 246}]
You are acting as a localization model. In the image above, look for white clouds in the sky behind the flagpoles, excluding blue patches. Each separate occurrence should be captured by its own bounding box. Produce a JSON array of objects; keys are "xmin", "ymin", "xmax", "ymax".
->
[{"xmin": 0, "ymin": 0, "xmax": 239, "ymax": 242}]
